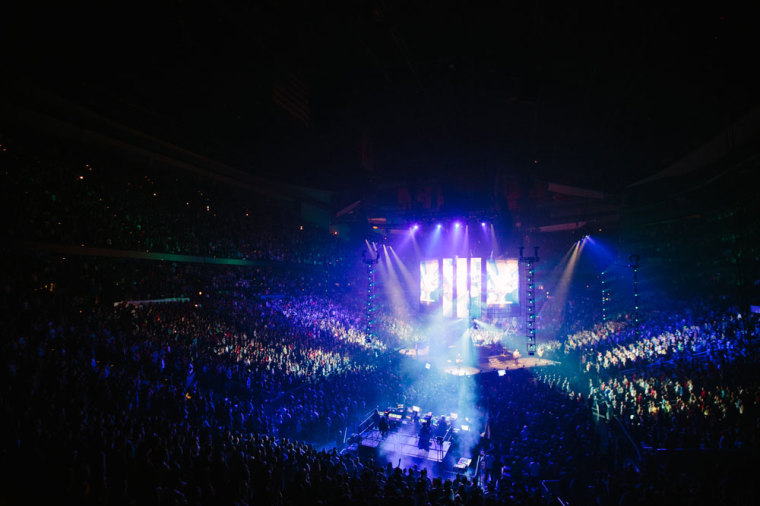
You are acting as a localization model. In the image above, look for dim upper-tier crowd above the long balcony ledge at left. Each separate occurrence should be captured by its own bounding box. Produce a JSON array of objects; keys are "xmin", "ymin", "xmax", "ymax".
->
[{"xmin": 0, "ymin": 138, "xmax": 345, "ymax": 265}]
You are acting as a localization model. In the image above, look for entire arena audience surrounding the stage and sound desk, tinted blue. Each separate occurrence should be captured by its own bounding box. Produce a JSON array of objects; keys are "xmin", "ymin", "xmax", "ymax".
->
[{"xmin": 0, "ymin": 136, "xmax": 760, "ymax": 505}]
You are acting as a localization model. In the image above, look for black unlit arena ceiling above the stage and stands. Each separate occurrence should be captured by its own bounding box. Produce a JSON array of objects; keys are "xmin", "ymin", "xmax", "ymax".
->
[{"xmin": 2, "ymin": 0, "xmax": 760, "ymax": 192}]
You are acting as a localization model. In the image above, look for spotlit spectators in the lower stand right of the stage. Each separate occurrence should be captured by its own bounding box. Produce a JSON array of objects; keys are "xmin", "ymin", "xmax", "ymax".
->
[{"xmin": 553, "ymin": 307, "xmax": 760, "ymax": 449}]
